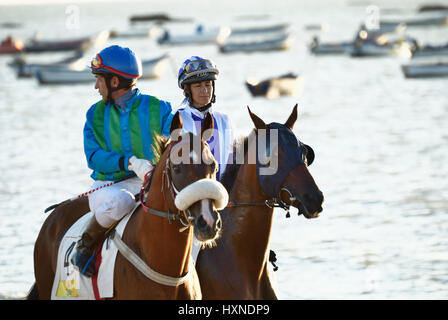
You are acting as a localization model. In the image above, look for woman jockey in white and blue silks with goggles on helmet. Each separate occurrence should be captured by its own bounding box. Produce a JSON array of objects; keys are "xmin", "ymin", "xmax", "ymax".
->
[{"xmin": 178, "ymin": 56, "xmax": 234, "ymax": 180}]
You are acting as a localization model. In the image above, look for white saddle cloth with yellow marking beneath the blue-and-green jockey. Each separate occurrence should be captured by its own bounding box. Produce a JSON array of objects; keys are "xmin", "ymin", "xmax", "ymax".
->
[{"xmin": 51, "ymin": 204, "xmax": 201, "ymax": 300}]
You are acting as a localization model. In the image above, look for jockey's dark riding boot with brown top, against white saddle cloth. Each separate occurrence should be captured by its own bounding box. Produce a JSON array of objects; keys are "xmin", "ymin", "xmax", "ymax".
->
[{"xmin": 70, "ymin": 215, "xmax": 108, "ymax": 277}]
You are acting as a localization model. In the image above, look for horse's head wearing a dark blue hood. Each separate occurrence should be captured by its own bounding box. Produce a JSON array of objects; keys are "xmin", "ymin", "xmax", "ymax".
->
[{"xmin": 248, "ymin": 105, "xmax": 324, "ymax": 218}]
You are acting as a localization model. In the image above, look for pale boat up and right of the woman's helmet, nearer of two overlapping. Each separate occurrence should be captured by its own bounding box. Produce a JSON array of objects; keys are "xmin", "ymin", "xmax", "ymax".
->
[{"xmin": 219, "ymin": 33, "xmax": 294, "ymax": 53}]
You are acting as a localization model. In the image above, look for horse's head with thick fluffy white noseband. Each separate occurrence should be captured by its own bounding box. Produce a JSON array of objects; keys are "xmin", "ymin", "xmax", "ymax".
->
[{"xmin": 160, "ymin": 113, "xmax": 228, "ymax": 241}]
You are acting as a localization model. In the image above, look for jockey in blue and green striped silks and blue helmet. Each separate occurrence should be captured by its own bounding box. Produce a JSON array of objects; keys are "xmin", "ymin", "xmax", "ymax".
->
[{"xmin": 71, "ymin": 45, "xmax": 173, "ymax": 277}]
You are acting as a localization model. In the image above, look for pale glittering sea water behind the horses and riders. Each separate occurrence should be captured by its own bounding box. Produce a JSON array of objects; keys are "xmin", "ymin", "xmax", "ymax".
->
[{"xmin": 0, "ymin": 0, "xmax": 448, "ymax": 300}]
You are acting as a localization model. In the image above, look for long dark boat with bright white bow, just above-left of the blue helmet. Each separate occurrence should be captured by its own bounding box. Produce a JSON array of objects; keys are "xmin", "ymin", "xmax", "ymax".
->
[{"xmin": 23, "ymin": 31, "xmax": 110, "ymax": 53}]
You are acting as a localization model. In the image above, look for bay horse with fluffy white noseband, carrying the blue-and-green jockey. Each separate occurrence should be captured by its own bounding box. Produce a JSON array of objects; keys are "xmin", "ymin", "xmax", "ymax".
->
[{"xmin": 28, "ymin": 113, "xmax": 228, "ymax": 299}]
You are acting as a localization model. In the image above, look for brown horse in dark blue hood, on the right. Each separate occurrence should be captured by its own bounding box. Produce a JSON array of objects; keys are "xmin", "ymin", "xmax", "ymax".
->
[{"xmin": 196, "ymin": 105, "xmax": 323, "ymax": 299}]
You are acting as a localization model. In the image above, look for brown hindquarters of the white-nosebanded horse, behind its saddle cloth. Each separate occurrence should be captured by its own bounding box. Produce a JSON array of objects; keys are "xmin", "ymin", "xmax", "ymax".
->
[{"xmin": 34, "ymin": 198, "xmax": 89, "ymax": 300}]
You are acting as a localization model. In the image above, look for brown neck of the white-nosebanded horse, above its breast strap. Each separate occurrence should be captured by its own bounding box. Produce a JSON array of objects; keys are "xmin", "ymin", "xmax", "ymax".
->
[{"xmin": 136, "ymin": 172, "xmax": 193, "ymax": 277}]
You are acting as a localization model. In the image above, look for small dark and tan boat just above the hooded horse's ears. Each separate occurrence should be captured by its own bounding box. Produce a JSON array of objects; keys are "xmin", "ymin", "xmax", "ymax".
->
[{"xmin": 246, "ymin": 73, "xmax": 303, "ymax": 99}]
